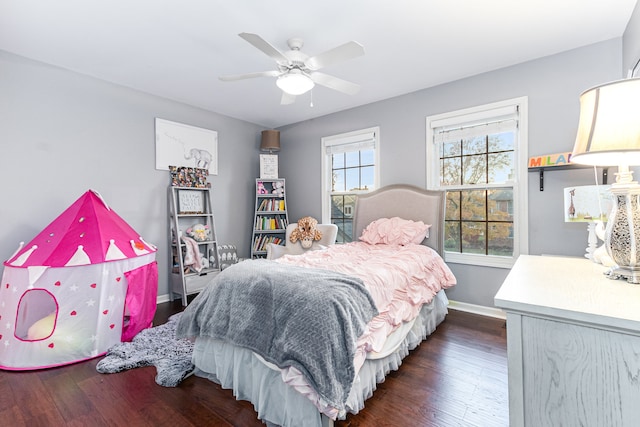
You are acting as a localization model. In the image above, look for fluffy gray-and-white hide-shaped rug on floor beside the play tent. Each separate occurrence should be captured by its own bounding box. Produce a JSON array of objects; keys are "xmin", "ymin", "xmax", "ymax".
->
[{"xmin": 96, "ymin": 313, "xmax": 194, "ymax": 387}]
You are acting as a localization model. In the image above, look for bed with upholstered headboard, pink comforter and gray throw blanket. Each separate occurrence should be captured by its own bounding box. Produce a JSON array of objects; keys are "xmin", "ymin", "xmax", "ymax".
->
[{"xmin": 178, "ymin": 185, "xmax": 455, "ymax": 427}]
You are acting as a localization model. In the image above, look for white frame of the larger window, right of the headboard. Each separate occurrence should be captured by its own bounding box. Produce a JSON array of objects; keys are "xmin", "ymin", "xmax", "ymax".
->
[{"xmin": 426, "ymin": 96, "xmax": 529, "ymax": 268}]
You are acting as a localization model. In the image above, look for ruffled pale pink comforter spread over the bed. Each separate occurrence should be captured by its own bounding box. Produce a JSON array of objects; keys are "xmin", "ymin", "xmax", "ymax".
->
[{"xmin": 276, "ymin": 242, "xmax": 456, "ymax": 419}]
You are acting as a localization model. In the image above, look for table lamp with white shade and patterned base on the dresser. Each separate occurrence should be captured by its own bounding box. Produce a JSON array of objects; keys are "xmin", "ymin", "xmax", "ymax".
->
[{"xmin": 571, "ymin": 78, "xmax": 640, "ymax": 284}]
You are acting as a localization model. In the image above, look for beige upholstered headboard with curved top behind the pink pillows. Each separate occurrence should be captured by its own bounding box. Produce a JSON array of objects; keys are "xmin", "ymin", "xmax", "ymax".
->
[{"xmin": 353, "ymin": 184, "xmax": 445, "ymax": 255}]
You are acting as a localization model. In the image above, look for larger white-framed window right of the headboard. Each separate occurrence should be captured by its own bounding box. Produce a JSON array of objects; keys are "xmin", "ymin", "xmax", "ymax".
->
[{"xmin": 427, "ymin": 97, "xmax": 528, "ymax": 268}]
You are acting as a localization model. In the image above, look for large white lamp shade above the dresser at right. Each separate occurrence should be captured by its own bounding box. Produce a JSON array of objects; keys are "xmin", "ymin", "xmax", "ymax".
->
[{"xmin": 571, "ymin": 78, "xmax": 640, "ymax": 166}]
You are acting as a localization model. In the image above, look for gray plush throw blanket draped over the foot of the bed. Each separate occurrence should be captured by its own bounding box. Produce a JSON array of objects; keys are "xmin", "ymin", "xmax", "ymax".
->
[{"xmin": 176, "ymin": 260, "xmax": 378, "ymax": 410}]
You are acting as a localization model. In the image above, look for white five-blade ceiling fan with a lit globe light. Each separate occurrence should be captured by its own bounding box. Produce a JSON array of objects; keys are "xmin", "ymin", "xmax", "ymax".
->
[{"xmin": 219, "ymin": 33, "xmax": 364, "ymax": 104}]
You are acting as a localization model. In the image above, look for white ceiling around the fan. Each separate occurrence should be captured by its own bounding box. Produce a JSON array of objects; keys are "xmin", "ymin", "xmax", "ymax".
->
[{"xmin": 0, "ymin": 0, "xmax": 637, "ymax": 128}]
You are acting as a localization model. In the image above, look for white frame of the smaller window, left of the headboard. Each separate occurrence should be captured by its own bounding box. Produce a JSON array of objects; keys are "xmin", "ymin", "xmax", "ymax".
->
[{"xmin": 320, "ymin": 126, "xmax": 380, "ymax": 236}]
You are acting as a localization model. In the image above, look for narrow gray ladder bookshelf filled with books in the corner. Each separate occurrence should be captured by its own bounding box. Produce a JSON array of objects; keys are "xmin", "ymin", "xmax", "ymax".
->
[{"xmin": 251, "ymin": 178, "xmax": 289, "ymax": 258}]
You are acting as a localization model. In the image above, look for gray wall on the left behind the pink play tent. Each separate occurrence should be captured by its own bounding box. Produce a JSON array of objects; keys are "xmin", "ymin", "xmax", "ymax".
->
[{"xmin": 0, "ymin": 51, "xmax": 261, "ymax": 295}]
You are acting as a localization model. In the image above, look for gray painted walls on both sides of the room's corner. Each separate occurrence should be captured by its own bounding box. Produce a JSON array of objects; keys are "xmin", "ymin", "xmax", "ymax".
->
[{"xmin": 0, "ymin": 7, "xmax": 640, "ymax": 306}]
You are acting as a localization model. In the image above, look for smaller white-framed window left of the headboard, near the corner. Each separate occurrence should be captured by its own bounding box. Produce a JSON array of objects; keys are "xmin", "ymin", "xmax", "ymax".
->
[{"xmin": 322, "ymin": 127, "xmax": 380, "ymax": 243}]
